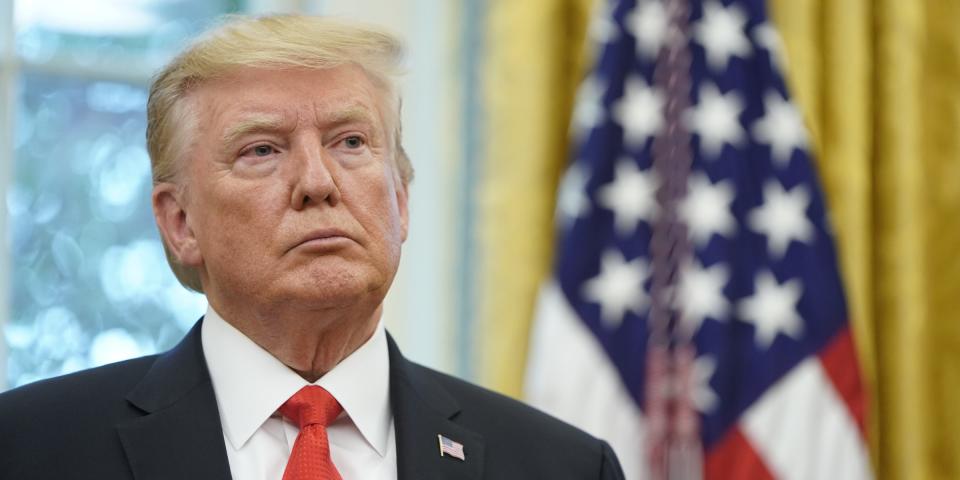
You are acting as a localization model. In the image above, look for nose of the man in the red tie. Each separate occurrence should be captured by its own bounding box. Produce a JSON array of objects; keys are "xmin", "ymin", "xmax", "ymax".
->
[{"xmin": 290, "ymin": 144, "xmax": 340, "ymax": 210}]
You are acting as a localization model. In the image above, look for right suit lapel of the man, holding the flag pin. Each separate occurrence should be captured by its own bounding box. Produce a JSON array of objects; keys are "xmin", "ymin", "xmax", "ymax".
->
[{"xmin": 388, "ymin": 337, "xmax": 484, "ymax": 480}]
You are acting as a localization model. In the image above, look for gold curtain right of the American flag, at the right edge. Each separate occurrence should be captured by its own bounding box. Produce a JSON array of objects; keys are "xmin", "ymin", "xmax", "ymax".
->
[{"xmin": 770, "ymin": 0, "xmax": 960, "ymax": 479}]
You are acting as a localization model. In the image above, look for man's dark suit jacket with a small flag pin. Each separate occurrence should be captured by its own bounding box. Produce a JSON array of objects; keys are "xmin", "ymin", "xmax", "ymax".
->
[{"xmin": 0, "ymin": 322, "xmax": 623, "ymax": 480}]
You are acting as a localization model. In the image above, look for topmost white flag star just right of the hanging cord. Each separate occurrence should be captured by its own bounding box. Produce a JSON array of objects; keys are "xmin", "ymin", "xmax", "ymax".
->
[{"xmin": 693, "ymin": 1, "xmax": 750, "ymax": 73}]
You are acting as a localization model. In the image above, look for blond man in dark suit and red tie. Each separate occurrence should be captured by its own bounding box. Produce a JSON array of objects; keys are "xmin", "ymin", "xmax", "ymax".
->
[{"xmin": 0, "ymin": 16, "xmax": 622, "ymax": 480}]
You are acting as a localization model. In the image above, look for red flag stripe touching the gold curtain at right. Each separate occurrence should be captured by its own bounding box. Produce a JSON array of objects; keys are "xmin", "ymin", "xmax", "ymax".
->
[{"xmin": 820, "ymin": 327, "xmax": 867, "ymax": 438}]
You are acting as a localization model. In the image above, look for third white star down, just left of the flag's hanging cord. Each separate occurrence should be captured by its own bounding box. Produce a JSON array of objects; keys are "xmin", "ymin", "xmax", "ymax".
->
[{"xmin": 597, "ymin": 157, "xmax": 660, "ymax": 235}]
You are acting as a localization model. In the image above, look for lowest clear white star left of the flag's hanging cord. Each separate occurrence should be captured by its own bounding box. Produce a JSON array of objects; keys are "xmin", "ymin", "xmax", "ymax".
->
[{"xmin": 583, "ymin": 249, "xmax": 650, "ymax": 328}]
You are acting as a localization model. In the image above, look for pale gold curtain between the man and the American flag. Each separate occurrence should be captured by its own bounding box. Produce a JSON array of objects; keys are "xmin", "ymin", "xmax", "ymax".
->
[{"xmin": 478, "ymin": 0, "xmax": 591, "ymax": 397}]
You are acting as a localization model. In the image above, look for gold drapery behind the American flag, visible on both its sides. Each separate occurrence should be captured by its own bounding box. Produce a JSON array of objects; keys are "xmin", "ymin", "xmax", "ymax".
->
[{"xmin": 479, "ymin": 0, "xmax": 960, "ymax": 479}]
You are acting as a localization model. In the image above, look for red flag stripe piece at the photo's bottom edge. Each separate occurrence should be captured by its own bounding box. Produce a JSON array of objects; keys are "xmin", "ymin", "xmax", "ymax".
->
[{"xmin": 704, "ymin": 427, "xmax": 773, "ymax": 480}]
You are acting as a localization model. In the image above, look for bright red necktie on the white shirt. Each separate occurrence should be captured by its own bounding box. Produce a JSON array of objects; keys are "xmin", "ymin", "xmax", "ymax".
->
[{"xmin": 280, "ymin": 385, "xmax": 343, "ymax": 480}]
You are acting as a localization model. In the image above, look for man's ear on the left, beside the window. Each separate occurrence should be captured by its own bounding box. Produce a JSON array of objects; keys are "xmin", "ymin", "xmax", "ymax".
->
[{"xmin": 152, "ymin": 183, "xmax": 203, "ymax": 267}]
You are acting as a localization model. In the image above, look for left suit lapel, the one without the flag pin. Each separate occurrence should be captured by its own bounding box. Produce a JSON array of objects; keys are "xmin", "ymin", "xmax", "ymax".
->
[{"xmin": 117, "ymin": 319, "xmax": 230, "ymax": 480}]
